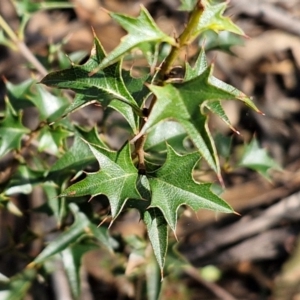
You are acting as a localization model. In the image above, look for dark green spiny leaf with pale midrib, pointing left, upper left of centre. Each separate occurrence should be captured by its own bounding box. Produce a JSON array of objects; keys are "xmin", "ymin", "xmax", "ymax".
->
[{"xmin": 41, "ymin": 31, "xmax": 140, "ymax": 132}]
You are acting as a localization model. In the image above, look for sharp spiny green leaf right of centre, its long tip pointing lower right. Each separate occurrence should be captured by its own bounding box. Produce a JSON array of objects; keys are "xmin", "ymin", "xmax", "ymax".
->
[{"xmin": 148, "ymin": 146, "xmax": 233, "ymax": 231}]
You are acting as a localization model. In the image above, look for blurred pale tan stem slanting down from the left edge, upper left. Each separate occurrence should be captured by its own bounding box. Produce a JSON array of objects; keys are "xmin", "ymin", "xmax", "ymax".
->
[{"xmin": 0, "ymin": 15, "xmax": 48, "ymax": 76}]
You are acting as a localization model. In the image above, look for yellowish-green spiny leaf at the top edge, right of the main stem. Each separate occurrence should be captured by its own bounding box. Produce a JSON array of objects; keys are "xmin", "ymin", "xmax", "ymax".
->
[{"xmin": 192, "ymin": 0, "xmax": 245, "ymax": 37}]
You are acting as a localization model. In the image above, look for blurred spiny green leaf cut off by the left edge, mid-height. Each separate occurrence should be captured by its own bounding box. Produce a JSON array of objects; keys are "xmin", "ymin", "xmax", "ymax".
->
[{"xmin": 0, "ymin": 98, "xmax": 30, "ymax": 157}]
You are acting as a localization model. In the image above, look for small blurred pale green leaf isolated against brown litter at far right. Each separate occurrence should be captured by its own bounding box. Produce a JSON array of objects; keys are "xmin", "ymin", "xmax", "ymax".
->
[{"xmin": 238, "ymin": 139, "xmax": 281, "ymax": 180}]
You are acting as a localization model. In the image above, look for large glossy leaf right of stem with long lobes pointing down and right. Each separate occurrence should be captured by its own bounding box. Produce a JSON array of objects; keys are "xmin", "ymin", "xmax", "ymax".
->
[{"xmin": 142, "ymin": 66, "xmax": 257, "ymax": 175}]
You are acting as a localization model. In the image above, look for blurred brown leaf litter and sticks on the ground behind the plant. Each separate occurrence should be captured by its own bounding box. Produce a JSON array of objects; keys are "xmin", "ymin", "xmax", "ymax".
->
[{"xmin": 0, "ymin": 0, "xmax": 300, "ymax": 300}]
